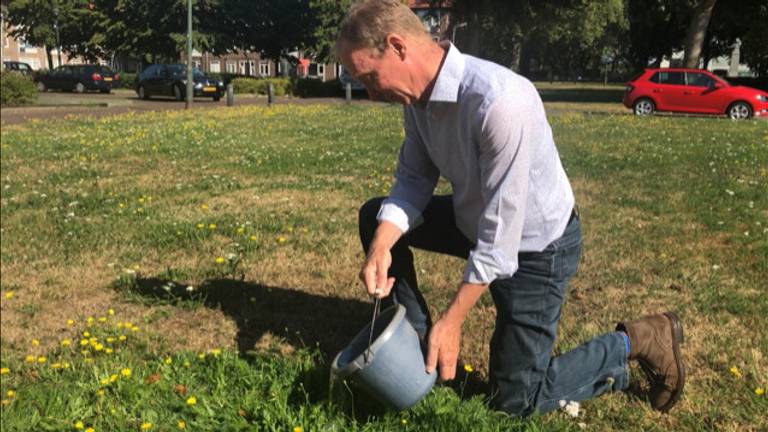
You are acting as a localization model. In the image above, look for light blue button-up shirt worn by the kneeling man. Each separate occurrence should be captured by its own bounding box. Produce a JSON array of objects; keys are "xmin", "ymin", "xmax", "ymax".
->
[{"xmin": 378, "ymin": 44, "xmax": 574, "ymax": 284}]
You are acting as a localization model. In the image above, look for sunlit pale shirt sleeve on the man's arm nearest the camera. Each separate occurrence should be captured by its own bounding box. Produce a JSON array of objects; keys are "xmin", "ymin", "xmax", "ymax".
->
[{"xmin": 464, "ymin": 95, "xmax": 544, "ymax": 284}]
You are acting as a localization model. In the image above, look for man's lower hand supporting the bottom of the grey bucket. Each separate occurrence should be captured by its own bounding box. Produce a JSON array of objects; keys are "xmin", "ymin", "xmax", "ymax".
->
[{"xmin": 426, "ymin": 316, "xmax": 461, "ymax": 381}]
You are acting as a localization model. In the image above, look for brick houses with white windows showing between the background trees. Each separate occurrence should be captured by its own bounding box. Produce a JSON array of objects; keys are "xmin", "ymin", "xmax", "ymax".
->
[{"xmin": 0, "ymin": 0, "xmax": 450, "ymax": 81}]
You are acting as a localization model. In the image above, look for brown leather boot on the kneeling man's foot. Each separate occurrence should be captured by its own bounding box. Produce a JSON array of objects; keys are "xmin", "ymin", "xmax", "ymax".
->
[{"xmin": 616, "ymin": 312, "xmax": 685, "ymax": 412}]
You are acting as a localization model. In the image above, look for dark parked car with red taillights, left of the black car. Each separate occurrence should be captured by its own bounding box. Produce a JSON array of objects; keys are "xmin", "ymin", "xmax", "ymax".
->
[{"xmin": 35, "ymin": 64, "xmax": 120, "ymax": 93}]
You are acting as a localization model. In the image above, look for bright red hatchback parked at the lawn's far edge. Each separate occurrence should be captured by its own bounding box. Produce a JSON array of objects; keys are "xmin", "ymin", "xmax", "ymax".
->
[{"xmin": 624, "ymin": 68, "xmax": 768, "ymax": 120}]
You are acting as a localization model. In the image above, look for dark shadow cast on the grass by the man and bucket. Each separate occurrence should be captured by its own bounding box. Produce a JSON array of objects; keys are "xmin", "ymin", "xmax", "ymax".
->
[{"xmin": 120, "ymin": 277, "xmax": 487, "ymax": 419}]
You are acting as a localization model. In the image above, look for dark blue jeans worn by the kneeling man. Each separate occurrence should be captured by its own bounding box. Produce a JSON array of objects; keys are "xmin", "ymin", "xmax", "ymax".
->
[{"xmin": 360, "ymin": 195, "xmax": 629, "ymax": 416}]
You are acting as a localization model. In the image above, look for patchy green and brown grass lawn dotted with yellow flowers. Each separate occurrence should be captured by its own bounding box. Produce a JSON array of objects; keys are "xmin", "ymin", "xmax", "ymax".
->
[{"xmin": 0, "ymin": 95, "xmax": 768, "ymax": 431}]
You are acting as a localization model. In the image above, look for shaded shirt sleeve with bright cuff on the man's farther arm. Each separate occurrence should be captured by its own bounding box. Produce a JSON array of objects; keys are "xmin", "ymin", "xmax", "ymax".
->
[{"xmin": 377, "ymin": 108, "xmax": 440, "ymax": 233}]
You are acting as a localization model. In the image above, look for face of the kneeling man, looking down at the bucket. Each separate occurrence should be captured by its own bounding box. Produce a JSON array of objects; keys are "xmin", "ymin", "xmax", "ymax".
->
[{"xmin": 338, "ymin": 42, "xmax": 418, "ymax": 105}]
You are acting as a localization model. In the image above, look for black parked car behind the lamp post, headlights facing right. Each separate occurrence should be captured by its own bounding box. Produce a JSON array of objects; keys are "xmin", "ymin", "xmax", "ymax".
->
[{"xmin": 136, "ymin": 64, "xmax": 225, "ymax": 101}]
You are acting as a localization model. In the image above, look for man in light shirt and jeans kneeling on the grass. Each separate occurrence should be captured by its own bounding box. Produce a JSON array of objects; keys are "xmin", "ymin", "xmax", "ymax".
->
[{"xmin": 336, "ymin": 0, "xmax": 685, "ymax": 415}]
